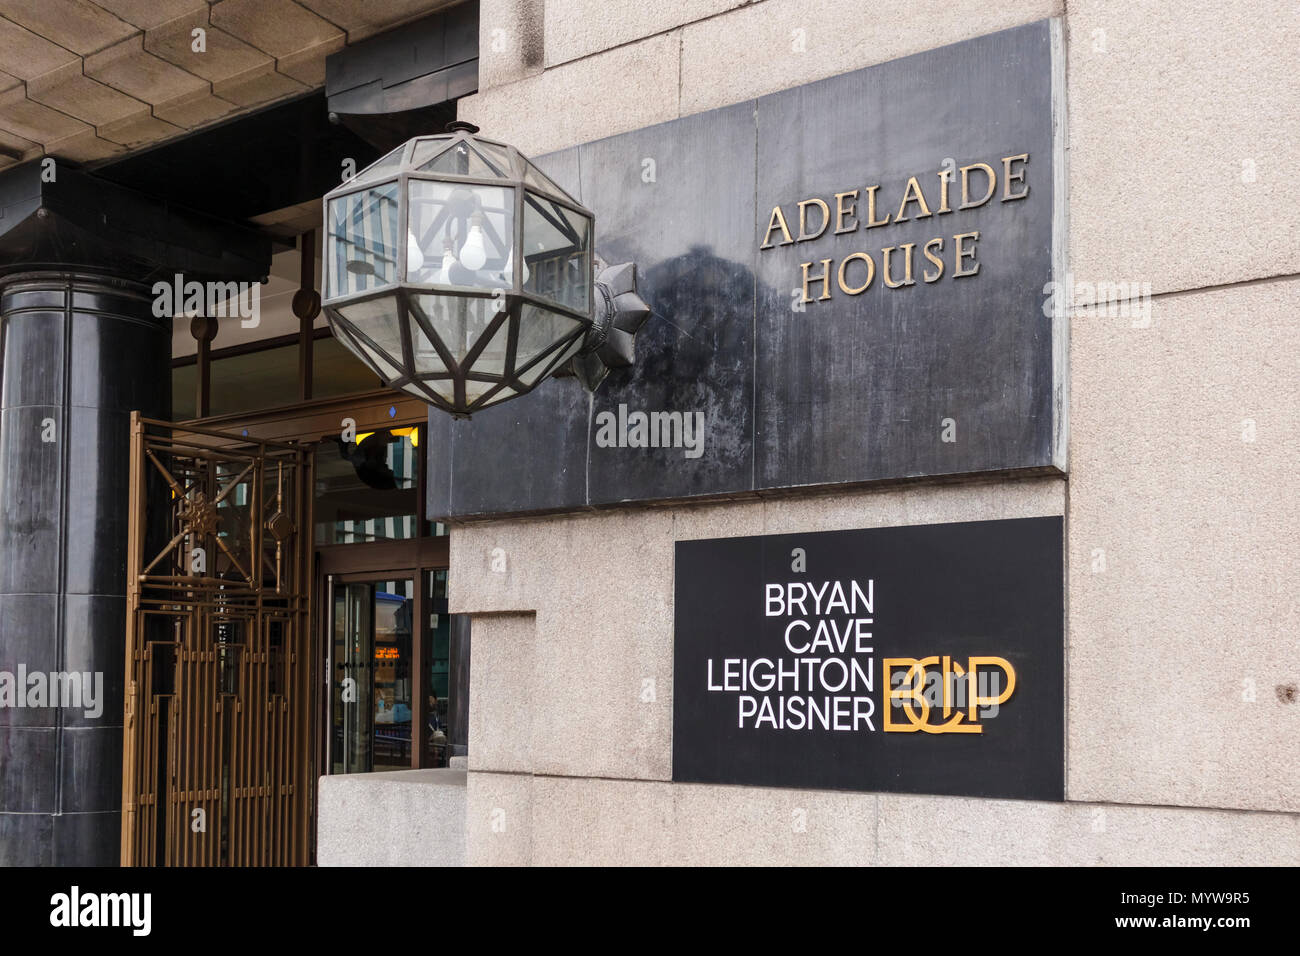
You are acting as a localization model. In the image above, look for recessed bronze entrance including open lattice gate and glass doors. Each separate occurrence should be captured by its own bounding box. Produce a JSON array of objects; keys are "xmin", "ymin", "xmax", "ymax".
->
[{"xmin": 122, "ymin": 237, "xmax": 469, "ymax": 865}]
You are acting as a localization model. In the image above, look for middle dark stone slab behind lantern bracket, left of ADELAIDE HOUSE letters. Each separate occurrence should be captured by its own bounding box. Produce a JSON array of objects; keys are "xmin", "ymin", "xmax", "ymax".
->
[{"xmin": 581, "ymin": 103, "xmax": 755, "ymax": 505}]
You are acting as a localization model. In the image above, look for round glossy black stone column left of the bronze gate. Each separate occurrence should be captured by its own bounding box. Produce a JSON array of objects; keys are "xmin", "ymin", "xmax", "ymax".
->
[{"xmin": 0, "ymin": 272, "xmax": 172, "ymax": 866}]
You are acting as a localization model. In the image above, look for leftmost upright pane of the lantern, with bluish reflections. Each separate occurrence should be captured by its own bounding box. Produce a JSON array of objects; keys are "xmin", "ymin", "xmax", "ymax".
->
[{"xmin": 325, "ymin": 182, "xmax": 398, "ymax": 299}]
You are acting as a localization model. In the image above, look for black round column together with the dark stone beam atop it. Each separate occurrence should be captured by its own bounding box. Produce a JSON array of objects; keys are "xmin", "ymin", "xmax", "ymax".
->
[{"xmin": 0, "ymin": 141, "xmax": 270, "ymax": 866}]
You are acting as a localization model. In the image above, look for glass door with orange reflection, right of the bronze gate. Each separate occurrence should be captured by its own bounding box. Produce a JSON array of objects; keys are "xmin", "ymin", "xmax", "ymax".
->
[{"xmin": 329, "ymin": 575, "xmax": 416, "ymax": 774}]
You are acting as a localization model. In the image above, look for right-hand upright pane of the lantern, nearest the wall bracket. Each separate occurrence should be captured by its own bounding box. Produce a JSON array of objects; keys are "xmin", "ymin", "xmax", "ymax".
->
[{"xmin": 523, "ymin": 193, "xmax": 592, "ymax": 313}]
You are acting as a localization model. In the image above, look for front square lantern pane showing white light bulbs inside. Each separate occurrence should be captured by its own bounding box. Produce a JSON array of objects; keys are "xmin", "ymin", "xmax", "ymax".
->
[{"xmin": 407, "ymin": 179, "xmax": 515, "ymax": 289}]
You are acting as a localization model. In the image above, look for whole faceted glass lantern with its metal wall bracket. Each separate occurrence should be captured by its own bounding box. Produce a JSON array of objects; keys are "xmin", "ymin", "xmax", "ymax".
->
[{"xmin": 322, "ymin": 122, "xmax": 649, "ymax": 415}]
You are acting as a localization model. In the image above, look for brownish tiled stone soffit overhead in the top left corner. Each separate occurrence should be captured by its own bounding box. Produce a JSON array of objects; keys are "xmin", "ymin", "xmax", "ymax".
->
[{"xmin": 0, "ymin": 0, "xmax": 462, "ymax": 169}]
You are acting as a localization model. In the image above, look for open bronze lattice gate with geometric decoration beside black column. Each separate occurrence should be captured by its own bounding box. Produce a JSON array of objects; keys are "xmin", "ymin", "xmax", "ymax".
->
[{"xmin": 122, "ymin": 414, "xmax": 313, "ymax": 866}]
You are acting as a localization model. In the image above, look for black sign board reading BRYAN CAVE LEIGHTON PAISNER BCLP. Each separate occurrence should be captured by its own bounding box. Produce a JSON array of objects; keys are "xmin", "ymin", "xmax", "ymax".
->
[{"xmin": 672, "ymin": 518, "xmax": 1065, "ymax": 800}]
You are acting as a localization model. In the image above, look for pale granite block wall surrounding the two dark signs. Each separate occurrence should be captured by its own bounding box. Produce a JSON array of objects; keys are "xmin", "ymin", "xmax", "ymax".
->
[{"xmin": 426, "ymin": 0, "xmax": 1300, "ymax": 865}]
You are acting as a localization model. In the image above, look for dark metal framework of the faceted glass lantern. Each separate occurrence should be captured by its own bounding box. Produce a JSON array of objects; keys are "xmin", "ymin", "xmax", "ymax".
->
[{"xmin": 322, "ymin": 122, "xmax": 650, "ymax": 416}]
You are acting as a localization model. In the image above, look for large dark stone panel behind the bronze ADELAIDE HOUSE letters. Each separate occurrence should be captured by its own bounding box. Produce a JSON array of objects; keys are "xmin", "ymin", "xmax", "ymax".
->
[{"xmin": 428, "ymin": 21, "xmax": 1065, "ymax": 519}]
